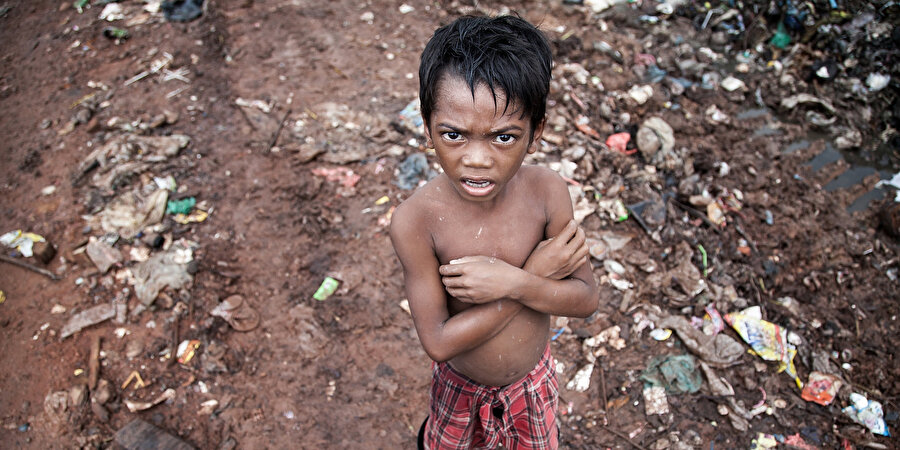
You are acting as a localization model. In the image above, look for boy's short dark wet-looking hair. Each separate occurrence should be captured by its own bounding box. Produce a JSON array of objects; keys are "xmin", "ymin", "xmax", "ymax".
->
[{"xmin": 419, "ymin": 16, "xmax": 553, "ymax": 131}]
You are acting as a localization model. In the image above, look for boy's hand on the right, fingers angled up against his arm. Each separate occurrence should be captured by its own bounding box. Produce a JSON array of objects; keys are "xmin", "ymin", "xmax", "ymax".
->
[{"xmin": 522, "ymin": 220, "xmax": 588, "ymax": 280}]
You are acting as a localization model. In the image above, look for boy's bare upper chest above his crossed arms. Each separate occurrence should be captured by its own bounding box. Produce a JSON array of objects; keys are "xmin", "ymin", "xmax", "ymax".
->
[{"xmin": 432, "ymin": 207, "xmax": 546, "ymax": 267}]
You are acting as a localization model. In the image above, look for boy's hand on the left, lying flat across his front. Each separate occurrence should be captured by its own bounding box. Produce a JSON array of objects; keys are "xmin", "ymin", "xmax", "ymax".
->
[{"xmin": 438, "ymin": 256, "xmax": 519, "ymax": 304}]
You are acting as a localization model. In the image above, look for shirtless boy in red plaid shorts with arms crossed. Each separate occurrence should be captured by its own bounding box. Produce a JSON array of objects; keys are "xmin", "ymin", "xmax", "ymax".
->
[{"xmin": 391, "ymin": 16, "xmax": 598, "ymax": 449}]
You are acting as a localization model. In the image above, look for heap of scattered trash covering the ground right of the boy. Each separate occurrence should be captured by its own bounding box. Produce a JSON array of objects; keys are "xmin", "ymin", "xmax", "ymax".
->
[{"xmin": 370, "ymin": 0, "xmax": 900, "ymax": 448}]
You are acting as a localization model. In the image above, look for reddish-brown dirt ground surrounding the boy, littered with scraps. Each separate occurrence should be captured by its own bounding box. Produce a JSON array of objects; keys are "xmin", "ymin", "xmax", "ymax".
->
[{"xmin": 0, "ymin": 0, "xmax": 900, "ymax": 448}]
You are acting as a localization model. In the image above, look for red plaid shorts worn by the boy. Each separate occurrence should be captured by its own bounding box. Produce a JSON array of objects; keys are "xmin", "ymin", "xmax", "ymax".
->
[{"xmin": 425, "ymin": 345, "xmax": 559, "ymax": 450}]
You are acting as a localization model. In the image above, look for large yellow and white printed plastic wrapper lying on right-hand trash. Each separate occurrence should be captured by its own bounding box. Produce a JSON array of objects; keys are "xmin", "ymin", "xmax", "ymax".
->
[{"xmin": 725, "ymin": 306, "xmax": 803, "ymax": 388}]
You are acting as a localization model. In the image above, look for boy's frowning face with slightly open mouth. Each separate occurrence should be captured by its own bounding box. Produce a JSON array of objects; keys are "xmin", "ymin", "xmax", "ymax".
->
[{"xmin": 425, "ymin": 76, "xmax": 544, "ymax": 202}]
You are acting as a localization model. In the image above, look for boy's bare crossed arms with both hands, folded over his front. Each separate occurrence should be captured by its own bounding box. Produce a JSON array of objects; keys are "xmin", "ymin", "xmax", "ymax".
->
[{"xmin": 391, "ymin": 186, "xmax": 597, "ymax": 362}]
